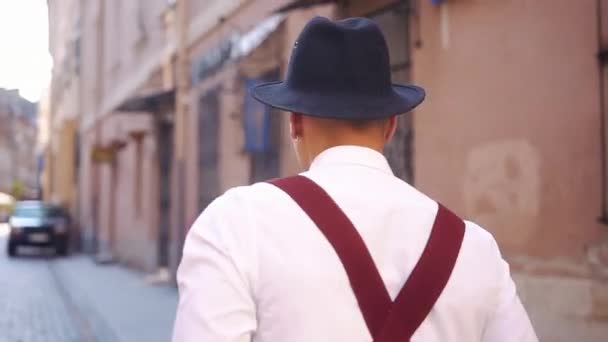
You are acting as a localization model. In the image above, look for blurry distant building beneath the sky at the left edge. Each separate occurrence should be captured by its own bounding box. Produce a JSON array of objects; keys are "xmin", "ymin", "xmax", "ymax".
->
[{"xmin": 0, "ymin": 88, "xmax": 38, "ymax": 198}]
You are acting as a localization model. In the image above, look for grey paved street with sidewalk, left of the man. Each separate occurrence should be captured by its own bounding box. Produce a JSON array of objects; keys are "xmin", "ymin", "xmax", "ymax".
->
[{"xmin": 0, "ymin": 224, "xmax": 177, "ymax": 342}]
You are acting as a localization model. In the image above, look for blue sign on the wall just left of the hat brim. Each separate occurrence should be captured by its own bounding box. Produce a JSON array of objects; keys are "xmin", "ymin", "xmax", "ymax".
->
[{"xmin": 243, "ymin": 79, "xmax": 271, "ymax": 153}]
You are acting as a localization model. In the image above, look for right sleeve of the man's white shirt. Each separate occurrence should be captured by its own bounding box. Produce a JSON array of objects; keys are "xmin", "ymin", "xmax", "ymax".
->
[{"xmin": 482, "ymin": 231, "xmax": 538, "ymax": 342}]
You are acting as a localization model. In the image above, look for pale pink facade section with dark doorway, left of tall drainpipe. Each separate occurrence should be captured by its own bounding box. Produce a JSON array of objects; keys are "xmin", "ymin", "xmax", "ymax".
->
[{"xmin": 78, "ymin": 0, "xmax": 174, "ymax": 271}]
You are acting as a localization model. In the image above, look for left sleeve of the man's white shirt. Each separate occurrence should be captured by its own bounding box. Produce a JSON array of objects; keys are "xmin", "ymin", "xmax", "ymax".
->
[{"xmin": 173, "ymin": 191, "xmax": 257, "ymax": 342}]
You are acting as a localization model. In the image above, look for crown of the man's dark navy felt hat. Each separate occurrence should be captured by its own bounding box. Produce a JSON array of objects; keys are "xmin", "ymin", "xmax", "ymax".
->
[{"xmin": 286, "ymin": 17, "xmax": 391, "ymax": 95}]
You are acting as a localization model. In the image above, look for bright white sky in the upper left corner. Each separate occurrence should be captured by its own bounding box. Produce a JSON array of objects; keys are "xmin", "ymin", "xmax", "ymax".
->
[{"xmin": 0, "ymin": 0, "xmax": 53, "ymax": 101}]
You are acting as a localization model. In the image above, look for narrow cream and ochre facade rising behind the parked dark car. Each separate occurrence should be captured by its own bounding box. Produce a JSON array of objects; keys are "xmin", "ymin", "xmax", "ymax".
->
[{"xmin": 45, "ymin": 0, "xmax": 82, "ymax": 249}]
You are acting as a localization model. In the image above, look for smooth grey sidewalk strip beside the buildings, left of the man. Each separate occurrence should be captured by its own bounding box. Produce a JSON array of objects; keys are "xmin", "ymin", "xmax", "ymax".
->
[{"xmin": 51, "ymin": 256, "xmax": 178, "ymax": 342}]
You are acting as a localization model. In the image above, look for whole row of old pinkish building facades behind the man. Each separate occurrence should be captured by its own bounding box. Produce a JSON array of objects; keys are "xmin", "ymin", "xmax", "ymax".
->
[{"xmin": 45, "ymin": 0, "xmax": 608, "ymax": 341}]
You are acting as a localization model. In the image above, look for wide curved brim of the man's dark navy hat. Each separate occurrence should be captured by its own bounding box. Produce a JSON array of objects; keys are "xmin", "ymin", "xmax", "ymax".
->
[{"xmin": 251, "ymin": 81, "xmax": 425, "ymax": 120}]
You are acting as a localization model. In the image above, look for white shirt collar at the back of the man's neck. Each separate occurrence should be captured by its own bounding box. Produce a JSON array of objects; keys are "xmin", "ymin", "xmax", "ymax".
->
[{"xmin": 310, "ymin": 145, "xmax": 393, "ymax": 175}]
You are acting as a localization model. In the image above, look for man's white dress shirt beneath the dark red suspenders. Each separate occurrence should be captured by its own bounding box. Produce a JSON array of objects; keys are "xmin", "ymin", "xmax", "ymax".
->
[{"xmin": 173, "ymin": 146, "xmax": 537, "ymax": 342}]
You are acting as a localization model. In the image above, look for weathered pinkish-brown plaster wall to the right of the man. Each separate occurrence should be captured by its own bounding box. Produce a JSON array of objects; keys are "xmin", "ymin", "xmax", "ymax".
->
[{"xmin": 413, "ymin": 0, "xmax": 608, "ymax": 341}]
